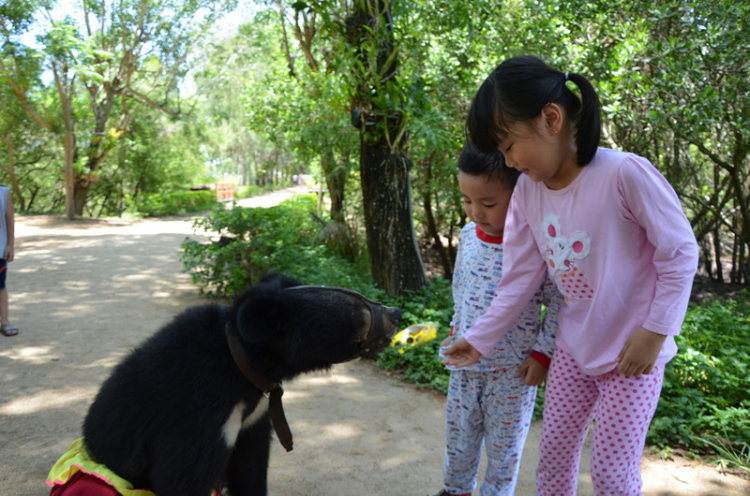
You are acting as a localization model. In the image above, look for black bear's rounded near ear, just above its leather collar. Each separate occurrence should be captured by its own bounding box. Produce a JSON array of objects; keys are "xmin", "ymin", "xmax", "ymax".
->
[{"xmin": 235, "ymin": 292, "xmax": 291, "ymax": 343}]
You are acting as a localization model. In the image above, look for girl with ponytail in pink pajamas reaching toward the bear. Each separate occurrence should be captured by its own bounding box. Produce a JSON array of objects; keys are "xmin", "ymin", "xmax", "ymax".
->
[{"xmin": 445, "ymin": 56, "xmax": 698, "ymax": 496}]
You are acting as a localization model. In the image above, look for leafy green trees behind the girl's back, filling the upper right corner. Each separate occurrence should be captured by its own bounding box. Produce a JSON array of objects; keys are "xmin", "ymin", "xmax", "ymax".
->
[{"xmin": 564, "ymin": 0, "xmax": 750, "ymax": 283}]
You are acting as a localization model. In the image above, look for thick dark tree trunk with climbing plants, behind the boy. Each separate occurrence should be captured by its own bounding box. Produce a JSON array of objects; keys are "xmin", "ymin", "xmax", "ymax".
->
[{"xmin": 347, "ymin": 0, "xmax": 427, "ymax": 296}]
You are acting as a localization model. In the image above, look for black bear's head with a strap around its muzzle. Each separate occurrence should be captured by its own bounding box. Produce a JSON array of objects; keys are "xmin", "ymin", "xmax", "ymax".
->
[{"xmin": 229, "ymin": 274, "xmax": 401, "ymax": 381}]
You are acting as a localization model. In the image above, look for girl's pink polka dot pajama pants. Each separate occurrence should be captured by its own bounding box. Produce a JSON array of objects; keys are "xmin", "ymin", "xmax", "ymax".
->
[{"xmin": 536, "ymin": 348, "xmax": 664, "ymax": 496}]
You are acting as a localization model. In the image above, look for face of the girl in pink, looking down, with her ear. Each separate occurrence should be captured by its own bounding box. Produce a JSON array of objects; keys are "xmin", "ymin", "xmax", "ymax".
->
[{"xmin": 498, "ymin": 103, "xmax": 580, "ymax": 189}]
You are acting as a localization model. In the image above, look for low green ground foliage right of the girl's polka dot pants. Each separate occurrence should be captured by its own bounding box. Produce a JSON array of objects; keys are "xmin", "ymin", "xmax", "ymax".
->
[{"xmin": 648, "ymin": 292, "xmax": 750, "ymax": 464}]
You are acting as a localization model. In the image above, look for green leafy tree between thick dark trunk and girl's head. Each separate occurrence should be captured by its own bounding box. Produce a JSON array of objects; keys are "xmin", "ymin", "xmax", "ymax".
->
[{"xmin": 400, "ymin": 0, "xmax": 516, "ymax": 278}]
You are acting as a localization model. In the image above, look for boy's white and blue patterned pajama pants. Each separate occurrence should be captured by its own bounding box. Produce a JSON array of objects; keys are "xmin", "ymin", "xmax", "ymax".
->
[{"xmin": 443, "ymin": 367, "xmax": 536, "ymax": 496}]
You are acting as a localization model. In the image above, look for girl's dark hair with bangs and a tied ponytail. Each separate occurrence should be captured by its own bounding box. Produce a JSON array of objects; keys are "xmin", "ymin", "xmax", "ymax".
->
[{"xmin": 466, "ymin": 56, "xmax": 602, "ymax": 166}]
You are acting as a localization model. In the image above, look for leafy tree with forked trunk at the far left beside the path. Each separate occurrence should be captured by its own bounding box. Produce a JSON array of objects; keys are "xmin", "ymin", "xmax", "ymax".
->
[{"xmin": 0, "ymin": 0, "xmax": 233, "ymax": 218}]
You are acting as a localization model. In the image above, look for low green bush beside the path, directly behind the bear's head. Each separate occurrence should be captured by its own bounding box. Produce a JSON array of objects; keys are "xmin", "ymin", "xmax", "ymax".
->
[{"xmin": 182, "ymin": 194, "xmax": 375, "ymax": 297}]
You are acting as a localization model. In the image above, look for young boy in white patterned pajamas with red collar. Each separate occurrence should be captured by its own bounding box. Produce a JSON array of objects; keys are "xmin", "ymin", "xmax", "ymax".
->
[{"xmin": 436, "ymin": 145, "xmax": 560, "ymax": 496}]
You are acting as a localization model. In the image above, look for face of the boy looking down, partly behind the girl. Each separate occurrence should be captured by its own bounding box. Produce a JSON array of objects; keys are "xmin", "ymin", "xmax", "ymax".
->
[{"xmin": 458, "ymin": 171, "xmax": 513, "ymax": 236}]
